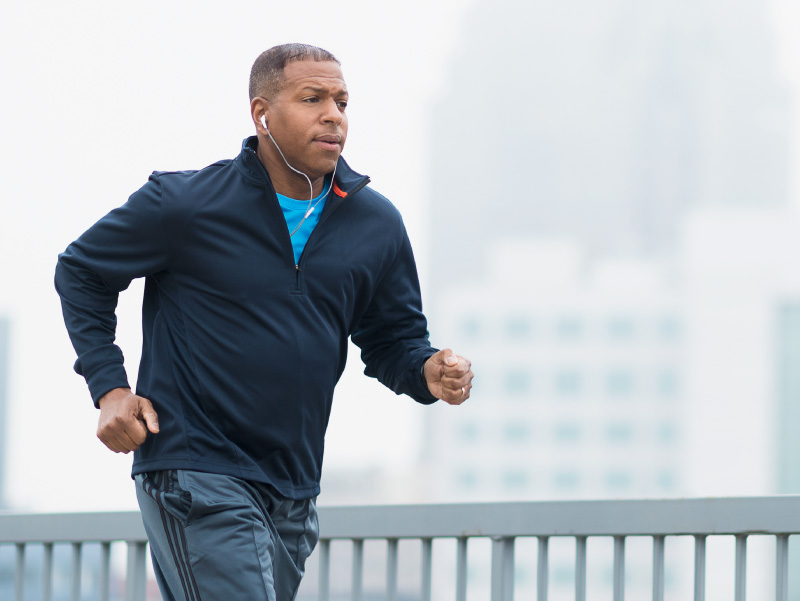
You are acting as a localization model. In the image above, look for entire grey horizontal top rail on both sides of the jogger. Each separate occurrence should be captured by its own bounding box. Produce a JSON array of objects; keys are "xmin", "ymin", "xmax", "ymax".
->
[{"xmin": 0, "ymin": 495, "xmax": 800, "ymax": 543}]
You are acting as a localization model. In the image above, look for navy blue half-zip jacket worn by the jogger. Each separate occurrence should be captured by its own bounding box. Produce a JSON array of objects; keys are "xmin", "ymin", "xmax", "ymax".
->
[{"xmin": 55, "ymin": 137, "xmax": 436, "ymax": 499}]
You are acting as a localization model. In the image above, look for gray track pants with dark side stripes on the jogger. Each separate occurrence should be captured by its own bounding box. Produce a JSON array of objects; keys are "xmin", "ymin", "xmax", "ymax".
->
[{"xmin": 136, "ymin": 470, "xmax": 319, "ymax": 601}]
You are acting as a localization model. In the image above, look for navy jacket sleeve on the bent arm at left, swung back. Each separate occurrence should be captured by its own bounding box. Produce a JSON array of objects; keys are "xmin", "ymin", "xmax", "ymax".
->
[{"xmin": 55, "ymin": 175, "xmax": 168, "ymax": 405}]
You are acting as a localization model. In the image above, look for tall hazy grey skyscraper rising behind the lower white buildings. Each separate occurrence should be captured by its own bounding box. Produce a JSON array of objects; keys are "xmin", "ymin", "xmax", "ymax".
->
[{"xmin": 430, "ymin": 0, "xmax": 790, "ymax": 290}]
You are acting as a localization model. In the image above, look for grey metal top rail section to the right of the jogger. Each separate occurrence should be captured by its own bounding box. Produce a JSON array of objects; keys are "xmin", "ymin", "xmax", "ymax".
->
[{"xmin": 320, "ymin": 495, "xmax": 800, "ymax": 538}]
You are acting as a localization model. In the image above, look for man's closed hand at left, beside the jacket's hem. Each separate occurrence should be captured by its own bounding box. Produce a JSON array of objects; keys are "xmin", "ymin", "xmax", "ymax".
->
[{"xmin": 97, "ymin": 388, "xmax": 158, "ymax": 453}]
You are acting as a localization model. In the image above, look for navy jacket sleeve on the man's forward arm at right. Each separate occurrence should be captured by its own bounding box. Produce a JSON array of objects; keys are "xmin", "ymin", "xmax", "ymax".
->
[{"xmin": 352, "ymin": 229, "xmax": 437, "ymax": 404}]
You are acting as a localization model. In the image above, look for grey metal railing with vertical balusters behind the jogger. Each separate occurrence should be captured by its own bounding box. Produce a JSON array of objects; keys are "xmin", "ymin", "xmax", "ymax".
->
[{"xmin": 0, "ymin": 496, "xmax": 800, "ymax": 601}]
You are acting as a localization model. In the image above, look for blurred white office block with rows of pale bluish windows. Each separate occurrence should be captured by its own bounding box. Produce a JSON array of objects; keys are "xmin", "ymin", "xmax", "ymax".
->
[{"xmin": 429, "ymin": 241, "xmax": 688, "ymax": 599}]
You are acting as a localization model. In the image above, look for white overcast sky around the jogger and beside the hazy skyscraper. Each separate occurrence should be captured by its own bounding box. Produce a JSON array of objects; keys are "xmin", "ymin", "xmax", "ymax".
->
[{"xmin": 0, "ymin": 0, "xmax": 800, "ymax": 510}]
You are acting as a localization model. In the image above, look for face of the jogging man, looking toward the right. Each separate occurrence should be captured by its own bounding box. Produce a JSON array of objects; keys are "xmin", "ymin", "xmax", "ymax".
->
[{"xmin": 267, "ymin": 59, "xmax": 348, "ymax": 180}]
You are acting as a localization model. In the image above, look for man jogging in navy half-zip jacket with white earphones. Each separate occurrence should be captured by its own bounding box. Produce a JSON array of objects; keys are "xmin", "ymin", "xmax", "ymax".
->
[{"xmin": 55, "ymin": 44, "xmax": 473, "ymax": 601}]
